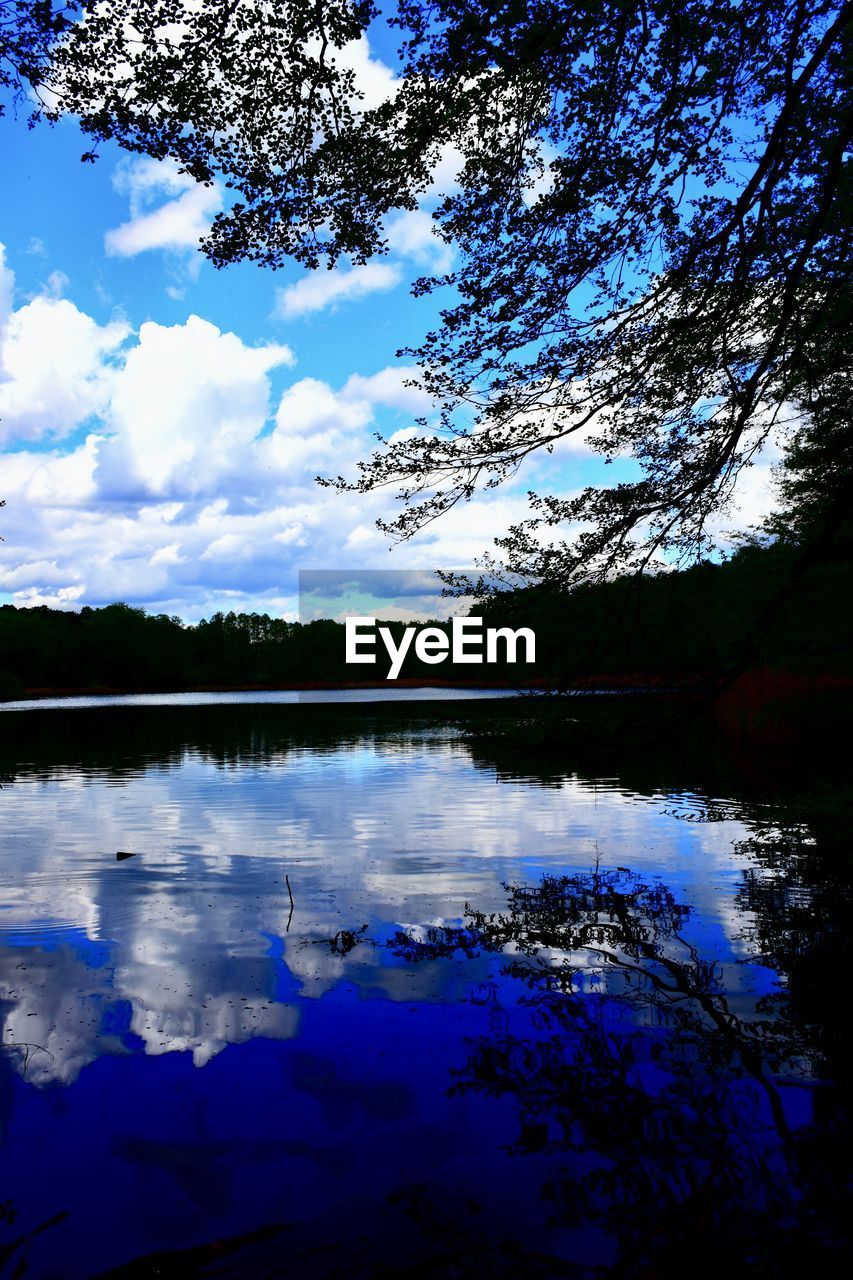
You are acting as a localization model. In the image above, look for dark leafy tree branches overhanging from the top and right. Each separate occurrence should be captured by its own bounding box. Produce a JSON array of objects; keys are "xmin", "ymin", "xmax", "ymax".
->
[{"xmin": 0, "ymin": 0, "xmax": 853, "ymax": 582}]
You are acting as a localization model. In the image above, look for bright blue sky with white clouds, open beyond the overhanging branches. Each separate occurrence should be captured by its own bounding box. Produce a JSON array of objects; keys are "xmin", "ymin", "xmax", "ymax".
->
[{"xmin": 0, "ymin": 32, "xmax": 766, "ymax": 621}]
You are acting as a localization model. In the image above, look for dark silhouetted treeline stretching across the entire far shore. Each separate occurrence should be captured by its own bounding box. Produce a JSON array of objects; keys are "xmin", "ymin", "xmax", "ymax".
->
[{"xmin": 0, "ymin": 543, "xmax": 853, "ymax": 699}]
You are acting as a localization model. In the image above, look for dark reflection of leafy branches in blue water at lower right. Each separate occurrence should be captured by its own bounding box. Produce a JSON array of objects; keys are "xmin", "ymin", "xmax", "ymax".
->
[{"xmin": 391, "ymin": 868, "xmax": 845, "ymax": 1276}]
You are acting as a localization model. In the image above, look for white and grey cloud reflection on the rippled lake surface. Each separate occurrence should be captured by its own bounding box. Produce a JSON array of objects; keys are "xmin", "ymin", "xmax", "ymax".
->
[{"xmin": 0, "ymin": 740, "xmax": 763, "ymax": 1083}]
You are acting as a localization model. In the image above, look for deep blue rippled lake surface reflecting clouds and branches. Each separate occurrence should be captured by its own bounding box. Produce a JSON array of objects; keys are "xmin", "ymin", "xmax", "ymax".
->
[{"xmin": 0, "ymin": 700, "xmax": 850, "ymax": 1280}]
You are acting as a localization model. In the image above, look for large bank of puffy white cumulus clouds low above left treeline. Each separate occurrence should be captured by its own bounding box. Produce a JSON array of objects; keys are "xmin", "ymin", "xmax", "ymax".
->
[{"xmin": 0, "ymin": 245, "xmax": 524, "ymax": 620}]
